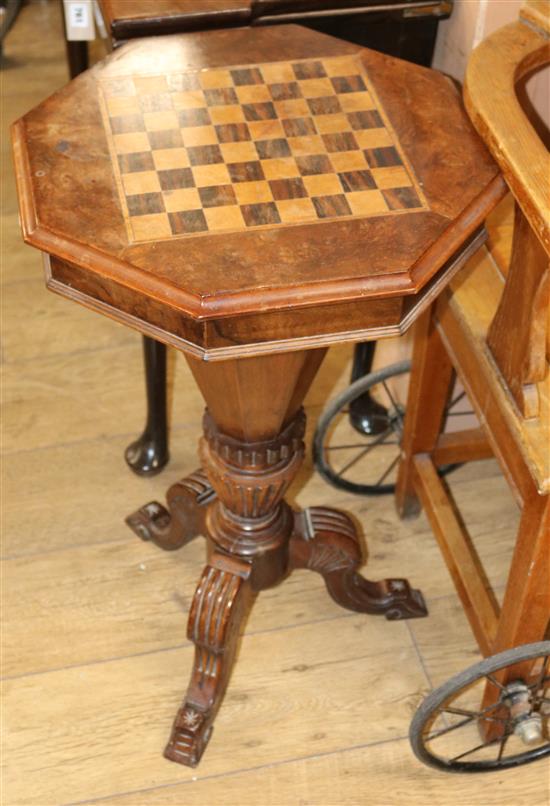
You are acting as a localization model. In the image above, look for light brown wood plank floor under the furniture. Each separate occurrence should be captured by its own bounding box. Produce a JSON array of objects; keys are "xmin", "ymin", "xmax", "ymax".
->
[{"xmin": 2, "ymin": 2, "xmax": 549, "ymax": 806}]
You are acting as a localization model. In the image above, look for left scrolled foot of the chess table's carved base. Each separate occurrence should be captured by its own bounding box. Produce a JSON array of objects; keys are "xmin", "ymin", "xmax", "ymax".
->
[{"xmin": 126, "ymin": 470, "xmax": 216, "ymax": 550}]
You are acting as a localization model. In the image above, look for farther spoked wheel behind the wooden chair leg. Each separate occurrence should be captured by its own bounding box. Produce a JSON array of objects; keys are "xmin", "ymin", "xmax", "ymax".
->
[{"xmin": 313, "ymin": 360, "xmax": 471, "ymax": 495}]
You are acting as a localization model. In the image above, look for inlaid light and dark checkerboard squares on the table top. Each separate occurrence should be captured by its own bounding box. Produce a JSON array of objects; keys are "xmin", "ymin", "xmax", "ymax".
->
[{"xmin": 100, "ymin": 57, "xmax": 426, "ymax": 242}]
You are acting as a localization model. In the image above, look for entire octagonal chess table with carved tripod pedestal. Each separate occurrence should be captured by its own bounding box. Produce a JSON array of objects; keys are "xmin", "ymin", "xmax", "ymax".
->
[{"xmin": 13, "ymin": 26, "xmax": 505, "ymax": 765}]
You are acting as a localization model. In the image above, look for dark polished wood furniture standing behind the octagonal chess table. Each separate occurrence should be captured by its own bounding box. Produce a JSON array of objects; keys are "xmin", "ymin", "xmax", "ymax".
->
[{"xmin": 87, "ymin": 0, "xmax": 452, "ymax": 475}]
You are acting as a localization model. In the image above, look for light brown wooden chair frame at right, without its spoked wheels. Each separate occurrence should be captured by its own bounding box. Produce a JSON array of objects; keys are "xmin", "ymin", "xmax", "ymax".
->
[{"xmin": 396, "ymin": 3, "xmax": 550, "ymax": 728}]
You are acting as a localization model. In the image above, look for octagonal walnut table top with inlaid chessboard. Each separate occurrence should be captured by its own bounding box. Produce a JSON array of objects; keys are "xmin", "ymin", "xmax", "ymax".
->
[{"xmin": 14, "ymin": 26, "xmax": 504, "ymax": 348}]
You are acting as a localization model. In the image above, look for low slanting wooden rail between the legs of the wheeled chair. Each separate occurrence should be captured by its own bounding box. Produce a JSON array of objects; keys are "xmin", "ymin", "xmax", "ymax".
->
[{"xmin": 414, "ymin": 454, "xmax": 499, "ymax": 655}]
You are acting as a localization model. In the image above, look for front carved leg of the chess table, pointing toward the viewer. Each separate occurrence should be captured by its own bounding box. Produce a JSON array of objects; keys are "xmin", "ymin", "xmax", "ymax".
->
[{"xmin": 164, "ymin": 552, "xmax": 253, "ymax": 767}]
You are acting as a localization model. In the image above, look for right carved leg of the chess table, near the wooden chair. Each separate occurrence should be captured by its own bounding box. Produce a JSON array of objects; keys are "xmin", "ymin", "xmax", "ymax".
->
[{"xmin": 290, "ymin": 507, "xmax": 428, "ymax": 621}]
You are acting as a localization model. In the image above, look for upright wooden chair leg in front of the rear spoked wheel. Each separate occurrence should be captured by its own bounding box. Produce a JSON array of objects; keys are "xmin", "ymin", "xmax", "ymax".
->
[{"xmin": 395, "ymin": 306, "xmax": 453, "ymax": 518}]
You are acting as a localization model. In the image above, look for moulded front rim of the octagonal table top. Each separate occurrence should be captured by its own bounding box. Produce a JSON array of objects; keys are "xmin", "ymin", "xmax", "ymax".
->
[{"xmin": 12, "ymin": 119, "xmax": 507, "ymax": 328}]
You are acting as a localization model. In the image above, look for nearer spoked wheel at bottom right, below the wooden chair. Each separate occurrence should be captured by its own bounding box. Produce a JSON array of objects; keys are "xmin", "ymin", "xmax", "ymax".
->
[{"xmin": 409, "ymin": 641, "xmax": 550, "ymax": 772}]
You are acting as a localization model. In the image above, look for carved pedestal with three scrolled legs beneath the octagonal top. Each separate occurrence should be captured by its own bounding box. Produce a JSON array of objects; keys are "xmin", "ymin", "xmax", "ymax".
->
[{"xmin": 128, "ymin": 350, "xmax": 426, "ymax": 766}]
